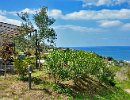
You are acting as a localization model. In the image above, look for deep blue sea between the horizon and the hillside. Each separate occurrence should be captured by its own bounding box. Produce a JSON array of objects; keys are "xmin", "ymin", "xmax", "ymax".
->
[{"xmin": 71, "ymin": 46, "xmax": 130, "ymax": 61}]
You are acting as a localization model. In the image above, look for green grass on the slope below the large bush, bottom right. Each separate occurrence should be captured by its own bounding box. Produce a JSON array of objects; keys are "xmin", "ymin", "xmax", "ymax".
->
[{"xmin": 51, "ymin": 77, "xmax": 130, "ymax": 100}]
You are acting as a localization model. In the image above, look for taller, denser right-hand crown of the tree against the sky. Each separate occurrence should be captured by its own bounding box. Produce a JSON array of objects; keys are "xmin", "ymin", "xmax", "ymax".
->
[{"xmin": 33, "ymin": 7, "xmax": 56, "ymax": 43}]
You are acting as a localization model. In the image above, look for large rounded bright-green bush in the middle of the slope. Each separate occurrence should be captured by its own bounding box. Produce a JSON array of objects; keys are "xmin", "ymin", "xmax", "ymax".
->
[{"xmin": 47, "ymin": 49, "xmax": 113, "ymax": 82}]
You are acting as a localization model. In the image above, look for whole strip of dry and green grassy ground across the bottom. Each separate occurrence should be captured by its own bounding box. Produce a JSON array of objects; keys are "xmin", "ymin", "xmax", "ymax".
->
[{"xmin": 0, "ymin": 70, "xmax": 130, "ymax": 100}]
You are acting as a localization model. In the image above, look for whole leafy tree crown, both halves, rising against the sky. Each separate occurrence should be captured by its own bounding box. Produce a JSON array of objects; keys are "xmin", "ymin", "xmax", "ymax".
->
[{"xmin": 15, "ymin": 7, "xmax": 56, "ymax": 51}]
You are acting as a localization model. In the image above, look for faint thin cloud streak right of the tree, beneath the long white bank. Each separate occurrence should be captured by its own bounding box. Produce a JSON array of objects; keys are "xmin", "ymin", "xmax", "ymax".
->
[{"xmin": 54, "ymin": 25, "xmax": 103, "ymax": 33}]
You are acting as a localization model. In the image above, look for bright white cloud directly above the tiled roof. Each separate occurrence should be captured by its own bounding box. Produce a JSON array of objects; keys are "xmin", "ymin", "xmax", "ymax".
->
[{"xmin": 0, "ymin": 15, "xmax": 21, "ymax": 25}]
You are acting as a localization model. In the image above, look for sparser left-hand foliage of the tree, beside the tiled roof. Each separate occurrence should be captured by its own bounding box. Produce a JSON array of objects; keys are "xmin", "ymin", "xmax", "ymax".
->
[{"xmin": 14, "ymin": 12, "xmax": 35, "ymax": 51}]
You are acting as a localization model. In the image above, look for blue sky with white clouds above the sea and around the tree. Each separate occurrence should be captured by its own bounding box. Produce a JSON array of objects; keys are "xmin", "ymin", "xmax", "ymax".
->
[{"xmin": 0, "ymin": 0, "xmax": 130, "ymax": 47}]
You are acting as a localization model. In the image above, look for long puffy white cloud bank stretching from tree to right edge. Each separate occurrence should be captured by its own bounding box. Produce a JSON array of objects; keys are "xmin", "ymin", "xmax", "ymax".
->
[{"xmin": 49, "ymin": 9, "xmax": 130, "ymax": 20}]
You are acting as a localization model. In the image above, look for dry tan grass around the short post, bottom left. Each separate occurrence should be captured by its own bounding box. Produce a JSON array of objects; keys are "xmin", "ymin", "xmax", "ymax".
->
[{"xmin": 0, "ymin": 75, "xmax": 67, "ymax": 100}]
